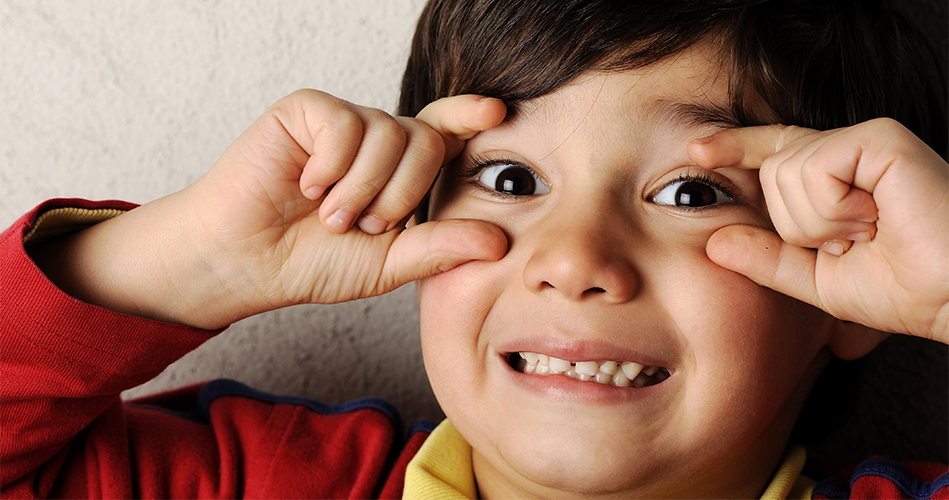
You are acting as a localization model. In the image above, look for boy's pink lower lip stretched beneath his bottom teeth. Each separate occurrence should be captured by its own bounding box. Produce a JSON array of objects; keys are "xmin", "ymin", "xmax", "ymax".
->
[{"xmin": 503, "ymin": 362, "xmax": 675, "ymax": 405}]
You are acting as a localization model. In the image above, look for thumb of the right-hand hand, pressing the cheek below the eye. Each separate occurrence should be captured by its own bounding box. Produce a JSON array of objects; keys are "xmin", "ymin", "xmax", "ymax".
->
[{"xmin": 705, "ymin": 225, "xmax": 824, "ymax": 309}]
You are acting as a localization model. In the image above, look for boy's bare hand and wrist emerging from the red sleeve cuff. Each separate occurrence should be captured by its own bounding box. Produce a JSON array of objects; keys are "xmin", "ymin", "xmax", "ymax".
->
[{"xmin": 35, "ymin": 90, "xmax": 507, "ymax": 328}]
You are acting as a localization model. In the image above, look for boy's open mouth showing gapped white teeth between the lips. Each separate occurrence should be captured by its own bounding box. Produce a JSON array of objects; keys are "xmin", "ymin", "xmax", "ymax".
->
[{"xmin": 508, "ymin": 352, "xmax": 670, "ymax": 387}]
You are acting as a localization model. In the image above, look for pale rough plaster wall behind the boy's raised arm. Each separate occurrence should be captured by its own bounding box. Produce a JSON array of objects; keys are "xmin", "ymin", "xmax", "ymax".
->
[{"xmin": 0, "ymin": 0, "xmax": 439, "ymax": 419}]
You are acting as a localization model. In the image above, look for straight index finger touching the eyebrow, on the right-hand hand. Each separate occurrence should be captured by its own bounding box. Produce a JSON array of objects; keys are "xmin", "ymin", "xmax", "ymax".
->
[{"xmin": 687, "ymin": 125, "xmax": 817, "ymax": 169}]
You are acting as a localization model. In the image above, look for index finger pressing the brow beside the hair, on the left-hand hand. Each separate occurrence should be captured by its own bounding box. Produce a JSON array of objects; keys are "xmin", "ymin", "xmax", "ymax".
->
[{"xmin": 416, "ymin": 95, "xmax": 507, "ymax": 163}]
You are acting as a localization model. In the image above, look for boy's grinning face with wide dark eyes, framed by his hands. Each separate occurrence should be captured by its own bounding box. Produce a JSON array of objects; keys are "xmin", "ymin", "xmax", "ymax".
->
[{"xmin": 419, "ymin": 46, "xmax": 832, "ymax": 497}]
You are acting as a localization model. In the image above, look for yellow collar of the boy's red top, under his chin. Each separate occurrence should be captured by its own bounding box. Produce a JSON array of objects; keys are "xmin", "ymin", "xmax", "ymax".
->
[{"xmin": 402, "ymin": 420, "xmax": 815, "ymax": 500}]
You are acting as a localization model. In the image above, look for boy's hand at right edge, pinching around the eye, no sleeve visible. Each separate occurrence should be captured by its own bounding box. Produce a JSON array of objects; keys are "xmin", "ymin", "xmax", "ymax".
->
[{"xmin": 689, "ymin": 119, "xmax": 949, "ymax": 343}]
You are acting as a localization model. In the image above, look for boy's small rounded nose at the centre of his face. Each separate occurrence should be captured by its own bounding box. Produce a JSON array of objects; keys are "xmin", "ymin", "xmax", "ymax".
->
[{"xmin": 524, "ymin": 206, "xmax": 640, "ymax": 304}]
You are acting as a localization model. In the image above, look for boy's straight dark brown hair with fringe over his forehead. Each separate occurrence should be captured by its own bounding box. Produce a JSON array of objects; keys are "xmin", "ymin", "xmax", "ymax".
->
[{"xmin": 399, "ymin": 0, "xmax": 949, "ymax": 157}]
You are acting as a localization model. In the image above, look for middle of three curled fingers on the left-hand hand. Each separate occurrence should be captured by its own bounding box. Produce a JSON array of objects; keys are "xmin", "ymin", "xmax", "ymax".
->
[{"xmin": 320, "ymin": 107, "xmax": 408, "ymax": 233}]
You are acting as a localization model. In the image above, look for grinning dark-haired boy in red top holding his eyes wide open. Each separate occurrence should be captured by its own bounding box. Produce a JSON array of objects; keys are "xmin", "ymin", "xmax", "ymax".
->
[{"xmin": 0, "ymin": 1, "xmax": 949, "ymax": 498}]
